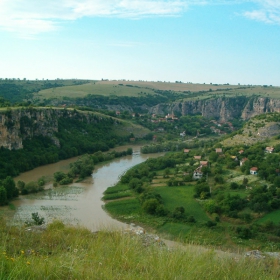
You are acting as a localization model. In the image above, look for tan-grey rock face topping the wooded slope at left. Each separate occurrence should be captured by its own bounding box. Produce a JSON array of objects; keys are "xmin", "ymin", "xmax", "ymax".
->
[{"xmin": 0, "ymin": 108, "xmax": 100, "ymax": 150}]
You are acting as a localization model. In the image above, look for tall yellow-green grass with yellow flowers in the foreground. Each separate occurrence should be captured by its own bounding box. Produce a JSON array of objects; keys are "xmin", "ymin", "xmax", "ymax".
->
[{"xmin": 0, "ymin": 221, "xmax": 280, "ymax": 280}]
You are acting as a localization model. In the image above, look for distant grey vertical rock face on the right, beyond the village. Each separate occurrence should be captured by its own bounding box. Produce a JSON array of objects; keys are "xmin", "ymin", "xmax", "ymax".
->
[{"xmin": 149, "ymin": 96, "xmax": 280, "ymax": 121}]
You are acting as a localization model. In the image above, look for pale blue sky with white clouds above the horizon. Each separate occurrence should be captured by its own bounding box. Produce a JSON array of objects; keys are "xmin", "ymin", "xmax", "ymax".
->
[{"xmin": 0, "ymin": 0, "xmax": 280, "ymax": 86}]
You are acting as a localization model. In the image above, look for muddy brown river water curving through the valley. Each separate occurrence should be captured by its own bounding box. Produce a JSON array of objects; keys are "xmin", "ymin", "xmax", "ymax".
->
[{"xmin": 13, "ymin": 146, "xmax": 162, "ymax": 231}]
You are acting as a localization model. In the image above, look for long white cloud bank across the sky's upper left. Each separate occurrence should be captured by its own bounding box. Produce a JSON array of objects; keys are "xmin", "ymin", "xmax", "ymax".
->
[{"xmin": 0, "ymin": 0, "xmax": 190, "ymax": 36}]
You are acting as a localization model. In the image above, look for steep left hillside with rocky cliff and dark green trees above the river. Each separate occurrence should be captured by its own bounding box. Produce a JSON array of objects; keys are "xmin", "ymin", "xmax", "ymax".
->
[{"xmin": 0, "ymin": 107, "xmax": 149, "ymax": 178}]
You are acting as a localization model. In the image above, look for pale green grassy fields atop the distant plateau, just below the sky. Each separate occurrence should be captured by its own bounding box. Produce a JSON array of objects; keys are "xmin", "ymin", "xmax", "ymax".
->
[{"xmin": 36, "ymin": 81, "xmax": 280, "ymax": 103}]
